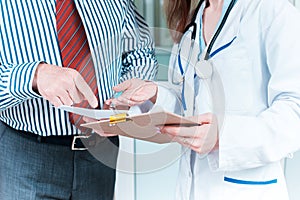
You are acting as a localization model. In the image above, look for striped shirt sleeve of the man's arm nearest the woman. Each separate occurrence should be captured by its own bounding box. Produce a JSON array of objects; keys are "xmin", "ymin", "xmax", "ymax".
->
[{"xmin": 121, "ymin": 0, "xmax": 158, "ymax": 81}]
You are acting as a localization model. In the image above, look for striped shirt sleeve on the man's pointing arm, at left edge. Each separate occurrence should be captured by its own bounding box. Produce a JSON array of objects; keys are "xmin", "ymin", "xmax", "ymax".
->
[{"xmin": 0, "ymin": 62, "xmax": 40, "ymax": 110}]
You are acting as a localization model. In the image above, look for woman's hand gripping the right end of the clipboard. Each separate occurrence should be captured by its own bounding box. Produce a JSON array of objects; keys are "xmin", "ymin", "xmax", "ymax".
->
[{"xmin": 160, "ymin": 113, "xmax": 219, "ymax": 154}]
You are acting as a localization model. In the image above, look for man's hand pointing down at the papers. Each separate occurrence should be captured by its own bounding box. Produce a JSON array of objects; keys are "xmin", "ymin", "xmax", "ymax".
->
[{"xmin": 32, "ymin": 64, "xmax": 98, "ymax": 108}]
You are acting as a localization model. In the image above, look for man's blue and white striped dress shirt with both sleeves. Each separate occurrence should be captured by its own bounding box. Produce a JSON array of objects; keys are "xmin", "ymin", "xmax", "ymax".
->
[{"xmin": 0, "ymin": 0, "xmax": 157, "ymax": 136}]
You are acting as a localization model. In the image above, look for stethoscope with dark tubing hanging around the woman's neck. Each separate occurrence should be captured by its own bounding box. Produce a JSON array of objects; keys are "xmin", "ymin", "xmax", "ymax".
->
[{"xmin": 171, "ymin": 0, "xmax": 236, "ymax": 85}]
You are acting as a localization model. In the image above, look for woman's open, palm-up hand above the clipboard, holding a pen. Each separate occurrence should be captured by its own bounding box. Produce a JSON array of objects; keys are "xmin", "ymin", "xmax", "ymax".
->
[{"xmin": 105, "ymin": 79, "xmax": 157, "ymax": 106}]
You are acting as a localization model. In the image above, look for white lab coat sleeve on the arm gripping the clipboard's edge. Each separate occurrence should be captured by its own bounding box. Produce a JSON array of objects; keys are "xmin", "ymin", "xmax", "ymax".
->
[{"xmin": 208, "ymin": 1, "xmax": 300, "ymax": 170}]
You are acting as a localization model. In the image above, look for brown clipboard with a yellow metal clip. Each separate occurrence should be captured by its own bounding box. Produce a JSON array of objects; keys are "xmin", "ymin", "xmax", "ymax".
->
[{"xmin": 81, "ymin": 111, "xmax": 201, "ymax": 144}]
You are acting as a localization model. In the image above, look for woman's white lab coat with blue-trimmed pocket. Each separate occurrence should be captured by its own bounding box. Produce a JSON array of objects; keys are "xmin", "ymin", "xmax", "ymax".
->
[{"xmin": 156, "ymin": 0, "xmax": 300, "ymax": 200}]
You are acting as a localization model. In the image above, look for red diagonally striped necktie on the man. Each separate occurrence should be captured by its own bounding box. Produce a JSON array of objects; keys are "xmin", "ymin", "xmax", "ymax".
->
[{"xmin": 56, "ymin": 0, "xmax": 98, "ymax": 131}]
